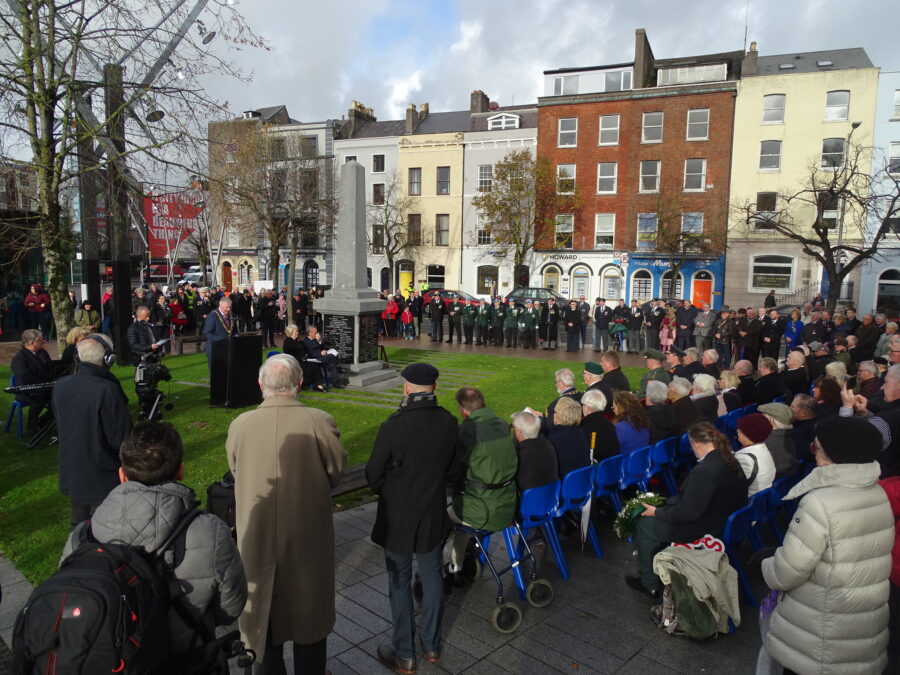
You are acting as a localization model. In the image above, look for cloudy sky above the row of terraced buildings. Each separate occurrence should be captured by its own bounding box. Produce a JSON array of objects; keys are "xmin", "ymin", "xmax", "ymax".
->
[{"xmin": 207, "ymin": 0, "xmax": 900, "ymax": 121}]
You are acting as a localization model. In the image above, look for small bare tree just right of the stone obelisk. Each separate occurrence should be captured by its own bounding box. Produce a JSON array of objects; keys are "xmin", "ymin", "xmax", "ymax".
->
[{"xmin": 367, "ymin": 171, "xmax": 414, "ymax": 290}]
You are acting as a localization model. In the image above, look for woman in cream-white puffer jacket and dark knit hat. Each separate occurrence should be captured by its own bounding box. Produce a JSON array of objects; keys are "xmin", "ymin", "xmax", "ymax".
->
[{"xmin": 762, "ymin": 416, "xmax": 894, "ymax": 675}]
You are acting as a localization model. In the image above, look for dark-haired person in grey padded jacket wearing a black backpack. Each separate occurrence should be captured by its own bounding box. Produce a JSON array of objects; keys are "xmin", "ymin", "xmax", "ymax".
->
[{"xmin": 13, "ymin": 421, "xmax": 247, "ymax": 674}]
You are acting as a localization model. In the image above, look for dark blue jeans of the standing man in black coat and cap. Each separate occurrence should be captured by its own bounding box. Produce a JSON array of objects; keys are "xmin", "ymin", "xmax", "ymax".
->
[{"xmin": 384, "ymin": 545, "xmax": 444, "ymax": 659}]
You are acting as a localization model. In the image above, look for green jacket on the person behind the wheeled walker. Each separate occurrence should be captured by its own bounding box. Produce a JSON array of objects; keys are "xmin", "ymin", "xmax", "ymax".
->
[{"xmin": 449, "ymin": 407, "xmax": 519, "ymax": 532}]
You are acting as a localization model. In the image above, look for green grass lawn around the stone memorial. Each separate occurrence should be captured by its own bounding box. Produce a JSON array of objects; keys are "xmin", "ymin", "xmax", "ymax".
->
[{"xmin": 0, "ymin": 348, "xmax": 640, "ymax": 583}]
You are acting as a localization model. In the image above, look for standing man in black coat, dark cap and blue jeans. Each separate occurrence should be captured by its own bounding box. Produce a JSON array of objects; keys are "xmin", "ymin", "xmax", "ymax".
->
[{"xmin": 366, "ymin": 363, "xmax": 459, "ymax": 672}]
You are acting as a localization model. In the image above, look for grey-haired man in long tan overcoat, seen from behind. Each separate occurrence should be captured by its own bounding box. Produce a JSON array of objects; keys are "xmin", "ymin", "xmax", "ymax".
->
[{"xmin": 225, "ymin": 354, "xmax": 347, "ymax": 674}]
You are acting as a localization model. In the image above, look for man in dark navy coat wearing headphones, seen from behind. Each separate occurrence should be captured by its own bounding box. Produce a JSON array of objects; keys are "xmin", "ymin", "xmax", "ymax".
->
[{"xmin": 53, "ymin": 334, "xmax": 131, "ymax": 528}]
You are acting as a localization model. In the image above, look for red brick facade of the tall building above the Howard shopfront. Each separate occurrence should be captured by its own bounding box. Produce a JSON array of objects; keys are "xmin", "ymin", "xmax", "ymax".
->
[{"xmin": 538, "ymin": 87, "xmax": 736, "ymax": 251}]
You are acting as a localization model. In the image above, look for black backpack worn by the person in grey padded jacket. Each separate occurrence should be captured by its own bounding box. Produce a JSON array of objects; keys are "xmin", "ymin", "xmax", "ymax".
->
[{"xmin": 13, "ymin": 508, "xmax": 200, "ymax": 675}]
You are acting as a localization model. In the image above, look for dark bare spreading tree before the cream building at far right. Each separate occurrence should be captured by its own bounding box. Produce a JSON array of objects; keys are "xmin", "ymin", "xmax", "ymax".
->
[{"xmin": 732, "ymin": 141, "xmax": 900, "ymax": 311}]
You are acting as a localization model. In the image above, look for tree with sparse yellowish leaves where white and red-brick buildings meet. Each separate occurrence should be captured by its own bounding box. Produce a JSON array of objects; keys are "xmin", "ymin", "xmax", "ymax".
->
[{"xmin": 472, "ymin": 150, "xmax": 581, "ymax": 286}]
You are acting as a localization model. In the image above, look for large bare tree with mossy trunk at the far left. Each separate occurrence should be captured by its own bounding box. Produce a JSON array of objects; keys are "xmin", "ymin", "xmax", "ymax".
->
[{"xmin": 0, "ymin": 0, "xmax": 264, "ymax": 335}]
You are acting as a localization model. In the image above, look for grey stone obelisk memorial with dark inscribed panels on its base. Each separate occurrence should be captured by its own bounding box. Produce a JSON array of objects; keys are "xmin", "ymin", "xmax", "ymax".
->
[{"xmin": 316, "ymin": 162, "xmax": 397, "ymax": 387}]
